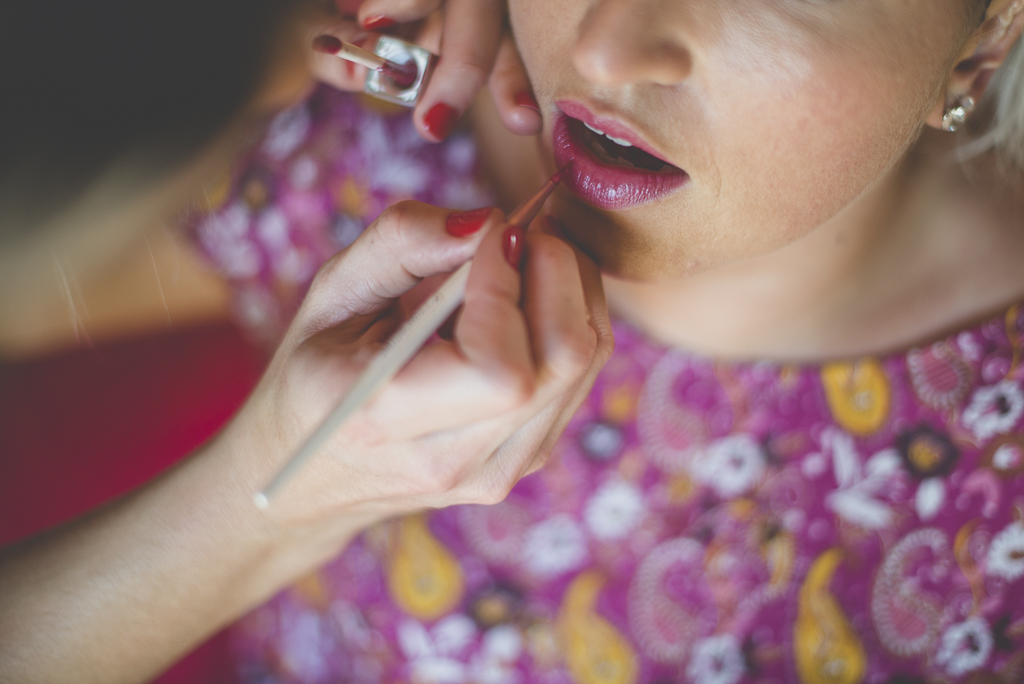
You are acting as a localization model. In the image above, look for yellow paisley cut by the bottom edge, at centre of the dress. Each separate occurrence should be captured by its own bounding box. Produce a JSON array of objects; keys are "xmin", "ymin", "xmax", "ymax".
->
[{"xmin": 558, "ymin": 570, "xmax": 638, "ymax": 684}]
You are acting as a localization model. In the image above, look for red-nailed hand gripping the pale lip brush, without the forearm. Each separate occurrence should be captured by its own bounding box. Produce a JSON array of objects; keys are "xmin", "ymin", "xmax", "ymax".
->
[{"xmin": 219, "ymin": 197, "xmax": 612, "ymax": 528}]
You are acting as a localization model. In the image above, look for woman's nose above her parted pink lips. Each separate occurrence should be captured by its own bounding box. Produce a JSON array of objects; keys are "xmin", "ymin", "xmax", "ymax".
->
[{"xmin": 572, "ymin": 0, "xmax": 693, "ymax": 87}]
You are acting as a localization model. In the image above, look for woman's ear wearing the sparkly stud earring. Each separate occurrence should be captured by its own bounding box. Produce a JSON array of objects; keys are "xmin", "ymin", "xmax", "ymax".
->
[{"xmin": 926, "ymin": 0, "xmax": 1024, "ymax": 129}]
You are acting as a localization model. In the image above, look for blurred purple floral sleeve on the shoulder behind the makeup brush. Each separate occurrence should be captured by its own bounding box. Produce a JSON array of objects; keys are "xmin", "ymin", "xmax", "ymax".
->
[{"xmin": 183, "ymin": 86, "xmax": 492, "ymax": 344}]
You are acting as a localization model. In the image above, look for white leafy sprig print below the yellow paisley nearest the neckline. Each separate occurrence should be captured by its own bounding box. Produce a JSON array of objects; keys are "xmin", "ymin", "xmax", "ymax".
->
[{"xmin": 821, "ymin": 429, "xmax": 901, "ymax": 529}]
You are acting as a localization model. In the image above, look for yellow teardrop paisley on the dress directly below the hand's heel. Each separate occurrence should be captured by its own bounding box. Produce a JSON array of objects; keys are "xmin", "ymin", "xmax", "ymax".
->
[{"xmin": 388, "ymin": 515, "xmax": 464, "ymax": 621}]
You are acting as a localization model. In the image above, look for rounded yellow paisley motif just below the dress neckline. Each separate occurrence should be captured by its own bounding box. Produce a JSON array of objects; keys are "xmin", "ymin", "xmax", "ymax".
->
[{"xmin": 821, "ymin": 358, "xmax": 891, "ymax": 435}]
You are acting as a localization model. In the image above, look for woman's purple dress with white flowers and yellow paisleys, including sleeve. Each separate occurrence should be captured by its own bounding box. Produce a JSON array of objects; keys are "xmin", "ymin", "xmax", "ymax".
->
[{"xmin": 194, "ymin": 91, "xmax": 1024, "ymax": 684}]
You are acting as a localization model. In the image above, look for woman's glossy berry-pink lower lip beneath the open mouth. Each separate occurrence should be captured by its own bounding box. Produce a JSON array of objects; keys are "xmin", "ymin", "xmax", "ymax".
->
[{"xmin": 552, "ymin": 112, "xmax": 689, "ymax": 211}]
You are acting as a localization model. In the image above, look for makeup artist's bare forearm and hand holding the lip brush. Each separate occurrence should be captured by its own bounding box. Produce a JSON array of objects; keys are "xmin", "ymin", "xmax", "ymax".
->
[{"xmin": 0, "ymin": 203, "xmax": 611, "ymax": 684}]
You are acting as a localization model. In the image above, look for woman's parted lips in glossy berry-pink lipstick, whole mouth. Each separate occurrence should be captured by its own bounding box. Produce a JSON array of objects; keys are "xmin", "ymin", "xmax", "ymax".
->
[{"xmin": 552, "ymin": 100, "xmax": 689, "ymax": 211}]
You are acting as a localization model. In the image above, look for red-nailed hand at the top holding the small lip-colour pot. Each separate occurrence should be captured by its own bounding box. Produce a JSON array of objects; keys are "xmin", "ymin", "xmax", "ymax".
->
[{"xmin": 310, "ymin": 0, "xmax": 542, "ymax": 141}]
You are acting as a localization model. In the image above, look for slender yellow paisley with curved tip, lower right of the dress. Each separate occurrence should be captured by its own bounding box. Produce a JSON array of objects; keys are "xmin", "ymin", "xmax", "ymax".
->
[{"xmin": 793, "ymin": 549, "xmax": 866, "ymax": 684}]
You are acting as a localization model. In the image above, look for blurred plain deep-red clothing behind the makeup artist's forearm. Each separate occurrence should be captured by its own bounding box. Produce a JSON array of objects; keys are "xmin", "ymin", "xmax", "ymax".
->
[{"xmin": 0, "ymin": 325, "xmax": 264, "ymax": 684}]
